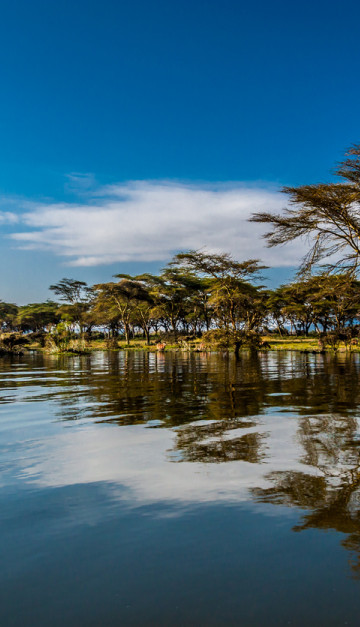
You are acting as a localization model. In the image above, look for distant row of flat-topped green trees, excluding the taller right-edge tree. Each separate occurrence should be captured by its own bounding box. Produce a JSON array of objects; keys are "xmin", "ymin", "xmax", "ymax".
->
[{"xmin": 0, "ymin": 251, "xmax": 360, "ymax": 352}]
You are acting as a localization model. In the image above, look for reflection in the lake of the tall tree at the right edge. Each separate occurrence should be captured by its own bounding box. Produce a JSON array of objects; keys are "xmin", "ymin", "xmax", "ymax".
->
[{"xmin": 252, "ymin": 410, "xmax": 360, "ymax": 579}]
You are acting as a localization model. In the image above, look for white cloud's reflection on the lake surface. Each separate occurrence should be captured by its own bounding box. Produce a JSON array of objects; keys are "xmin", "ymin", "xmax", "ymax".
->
[{"xmin": 19, "ymin": 413, "xmax": 320, "ymax": 506}]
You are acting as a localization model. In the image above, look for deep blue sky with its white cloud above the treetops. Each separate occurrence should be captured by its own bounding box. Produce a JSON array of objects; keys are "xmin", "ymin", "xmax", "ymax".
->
[{"xmin": 0, "ymin": 0, "xmax": 360, "ymax": 302}]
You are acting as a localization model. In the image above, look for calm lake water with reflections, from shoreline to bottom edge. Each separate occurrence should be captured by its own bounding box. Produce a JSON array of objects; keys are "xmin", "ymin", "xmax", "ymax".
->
[{"xmin": 0, "ymin": 352, "xmax": 360, "ymax": 627}]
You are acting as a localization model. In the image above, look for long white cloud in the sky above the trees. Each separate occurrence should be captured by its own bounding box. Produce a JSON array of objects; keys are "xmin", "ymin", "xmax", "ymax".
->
[{"xmin": 7, "ymin": 181, "xmax": 303, "ymax": 266}]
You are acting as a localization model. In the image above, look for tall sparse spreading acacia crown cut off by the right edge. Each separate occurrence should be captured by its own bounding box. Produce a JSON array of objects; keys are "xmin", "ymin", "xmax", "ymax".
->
[{"xmin": 250, "ymin": 144, "xmax": 360, "ymax": 272}]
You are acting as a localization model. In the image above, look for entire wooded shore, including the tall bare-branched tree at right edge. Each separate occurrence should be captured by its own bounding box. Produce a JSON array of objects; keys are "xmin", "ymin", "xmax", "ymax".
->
[{"xmin": 0, "ymin": 144, "xmax": 360, "ymax": 354}]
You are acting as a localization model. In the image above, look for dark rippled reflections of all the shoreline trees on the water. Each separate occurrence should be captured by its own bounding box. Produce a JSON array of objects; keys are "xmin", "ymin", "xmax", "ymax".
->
[{"xmin": 0, "ymin": 352, "xmax": 360, "ymax": 577}]
